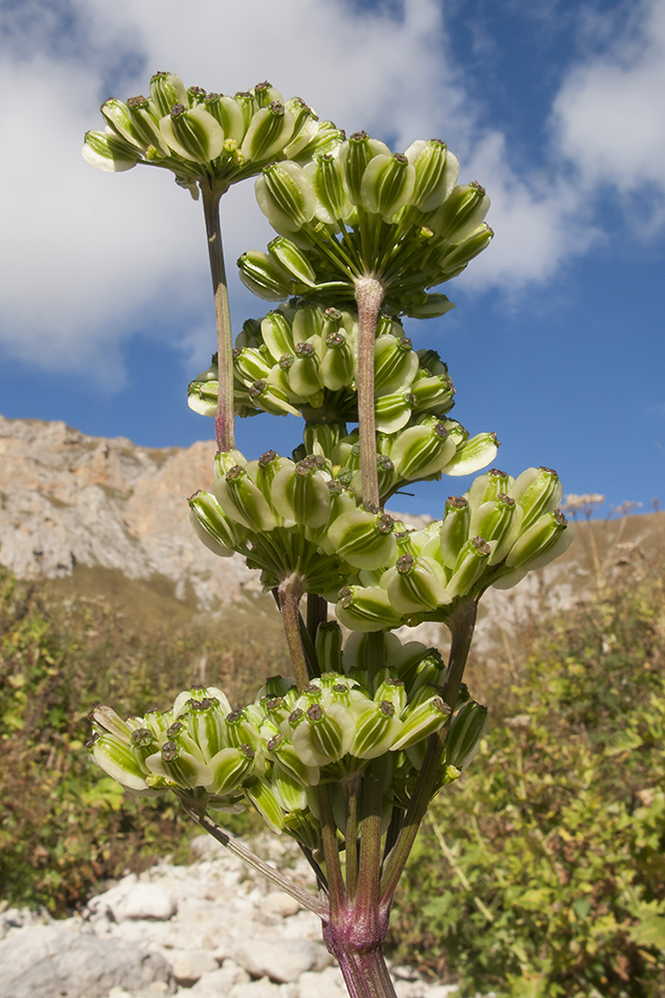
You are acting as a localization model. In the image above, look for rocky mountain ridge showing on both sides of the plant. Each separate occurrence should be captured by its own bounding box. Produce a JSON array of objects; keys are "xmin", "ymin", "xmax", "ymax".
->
[{"xmin": 0, "ymin": 416, "xmax": 665, "ymax": 659}]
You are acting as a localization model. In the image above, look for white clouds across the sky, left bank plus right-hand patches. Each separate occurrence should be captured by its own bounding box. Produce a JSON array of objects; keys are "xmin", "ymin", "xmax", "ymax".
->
[{"xmin": 0, "ymin": 0, "xmax": 665, "ymax": 387}]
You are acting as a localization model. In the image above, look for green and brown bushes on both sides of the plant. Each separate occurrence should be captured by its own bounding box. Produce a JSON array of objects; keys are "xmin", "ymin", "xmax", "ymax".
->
[{"xmin": 0, "ymin": 532, "xmax": 665, "ymax": 998}]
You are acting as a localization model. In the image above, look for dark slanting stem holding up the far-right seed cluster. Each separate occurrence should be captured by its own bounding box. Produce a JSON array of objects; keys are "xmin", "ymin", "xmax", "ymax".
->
[{"xmin": 380, "ymin": 600, "xmax": 478, "ymax": 911}]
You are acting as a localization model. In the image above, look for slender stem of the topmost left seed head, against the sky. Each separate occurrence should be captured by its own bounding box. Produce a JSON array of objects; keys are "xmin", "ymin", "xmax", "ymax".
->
[{"xmin": 201, "ymin": 184, "xmax": 235, "ymax": 453}]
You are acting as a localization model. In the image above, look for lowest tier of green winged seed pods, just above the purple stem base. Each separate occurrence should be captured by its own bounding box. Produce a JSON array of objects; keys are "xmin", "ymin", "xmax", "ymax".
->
[{"xmin": 89, "ymin": 623, "xmax": 486, "ymax": 848}]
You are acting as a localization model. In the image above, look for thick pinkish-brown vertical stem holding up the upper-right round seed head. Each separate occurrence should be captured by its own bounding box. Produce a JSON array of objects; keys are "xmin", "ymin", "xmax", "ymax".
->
[{"xmin": 355, "ymin": 277, "xmax": 385, "ymax": 509}]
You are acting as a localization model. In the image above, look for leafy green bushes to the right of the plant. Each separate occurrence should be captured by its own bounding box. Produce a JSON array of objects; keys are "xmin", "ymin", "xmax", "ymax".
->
[{"xmin": 392, "ymin": 562, "xmax": 665, "ymax": 998}]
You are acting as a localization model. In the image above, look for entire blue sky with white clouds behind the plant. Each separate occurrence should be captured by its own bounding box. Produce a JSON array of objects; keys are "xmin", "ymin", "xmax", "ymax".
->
[{"xmin": 0, "ymin": 0, "xmax": 665, "ymax": 516}]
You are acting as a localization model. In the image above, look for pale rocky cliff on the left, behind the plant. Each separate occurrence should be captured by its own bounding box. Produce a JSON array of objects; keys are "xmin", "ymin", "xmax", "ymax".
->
[{"xmin": 0, "ymin": 416, "xmax": 258, "ymax": 609}]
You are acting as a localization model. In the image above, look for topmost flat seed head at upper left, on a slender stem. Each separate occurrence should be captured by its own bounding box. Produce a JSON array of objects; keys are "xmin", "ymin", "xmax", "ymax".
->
[{"xmin": 83, "ymin": 73, "xmax": 344, "ymax": 198}]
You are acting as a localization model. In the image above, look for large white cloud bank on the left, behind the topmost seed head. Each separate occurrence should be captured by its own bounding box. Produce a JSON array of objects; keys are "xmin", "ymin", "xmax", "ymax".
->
[{"xmin": 0, "ymin": 0, "xmax": 462, "ymax": 384}]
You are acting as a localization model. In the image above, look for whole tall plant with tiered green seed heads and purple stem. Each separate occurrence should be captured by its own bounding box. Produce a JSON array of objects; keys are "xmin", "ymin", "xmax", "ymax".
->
[{"xmin": 83, "ymin": 73, "xmax": 572, "ymax": 998}]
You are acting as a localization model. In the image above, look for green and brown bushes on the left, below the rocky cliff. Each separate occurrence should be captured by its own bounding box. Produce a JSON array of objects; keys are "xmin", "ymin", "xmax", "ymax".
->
[{"xmin": 0, "ymin": 570, "xmax": 285, "ymax": 913}]
